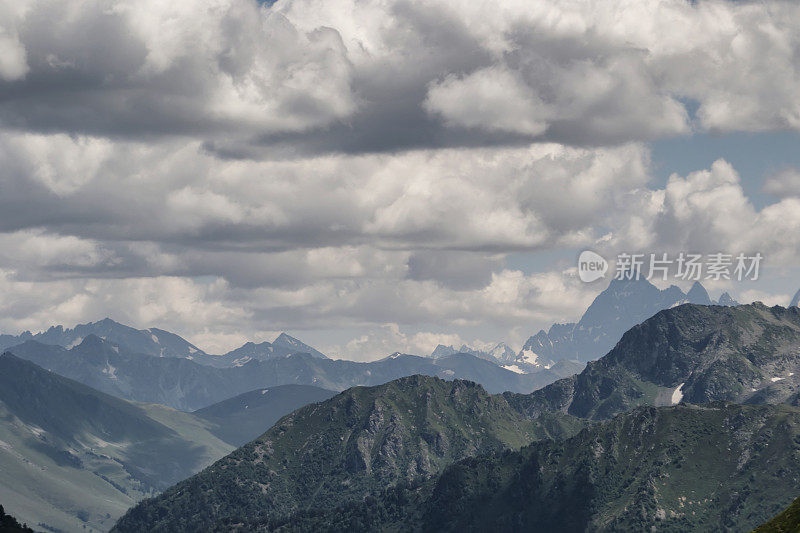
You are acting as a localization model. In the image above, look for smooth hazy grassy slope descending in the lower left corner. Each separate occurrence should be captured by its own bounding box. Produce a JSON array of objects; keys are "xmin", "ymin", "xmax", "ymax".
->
[{"xmin": 0, "ymin": 354, "xmax": 233, "ymax": 531}]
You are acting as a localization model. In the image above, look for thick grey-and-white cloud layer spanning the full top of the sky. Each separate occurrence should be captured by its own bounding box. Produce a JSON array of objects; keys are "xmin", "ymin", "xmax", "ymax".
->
[{"xmin": 0, "ymin": 0, "xmax": 800, "ymax": 154}]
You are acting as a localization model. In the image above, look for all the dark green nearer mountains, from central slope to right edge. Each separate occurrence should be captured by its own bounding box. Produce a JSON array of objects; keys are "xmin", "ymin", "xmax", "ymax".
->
[{"xmin": 116, "ymin": 304, "xmax": 800, "ymax": 531}]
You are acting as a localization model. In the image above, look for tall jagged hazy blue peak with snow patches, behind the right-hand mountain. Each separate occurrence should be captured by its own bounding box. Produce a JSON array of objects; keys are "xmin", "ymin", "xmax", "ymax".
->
[{"xmin": 513, "ymin": 279, "xmax": 737, "ymax": 364}]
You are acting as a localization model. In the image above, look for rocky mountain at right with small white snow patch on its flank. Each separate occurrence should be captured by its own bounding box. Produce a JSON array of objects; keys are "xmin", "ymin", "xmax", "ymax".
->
[{"xmin": 507, "ymin": 303, "xmax": 800, "ymax": 420}]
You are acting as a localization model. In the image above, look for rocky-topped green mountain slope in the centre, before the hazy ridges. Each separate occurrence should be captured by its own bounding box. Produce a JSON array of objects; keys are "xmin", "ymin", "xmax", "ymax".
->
[{"xmin": 115, "ymin": 376, "xmax": 581, "ymax": 531}]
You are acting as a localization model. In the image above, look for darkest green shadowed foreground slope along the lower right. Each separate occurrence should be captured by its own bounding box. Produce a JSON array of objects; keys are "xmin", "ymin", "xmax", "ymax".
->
[{"xmin": 276, "ymin": 403, "xmax": 800, "ymax": 533}]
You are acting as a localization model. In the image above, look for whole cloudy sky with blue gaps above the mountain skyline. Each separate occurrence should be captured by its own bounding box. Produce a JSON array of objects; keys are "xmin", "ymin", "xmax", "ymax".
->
[{"xmin": 0, "ymin": 0, "xmax": 800, "ymax": 361}]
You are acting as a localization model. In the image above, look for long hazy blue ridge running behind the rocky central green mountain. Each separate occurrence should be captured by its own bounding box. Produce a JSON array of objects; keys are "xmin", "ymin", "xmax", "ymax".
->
[{"xmin": 4, "ymin": 335, "xmax": 570, "ymax": 411}]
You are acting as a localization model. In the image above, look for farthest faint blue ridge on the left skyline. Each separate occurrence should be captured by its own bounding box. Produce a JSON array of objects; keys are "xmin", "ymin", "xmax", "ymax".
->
[{"xmin": 0, "ymin": 318, "xmax": 206, "ymax": 359}]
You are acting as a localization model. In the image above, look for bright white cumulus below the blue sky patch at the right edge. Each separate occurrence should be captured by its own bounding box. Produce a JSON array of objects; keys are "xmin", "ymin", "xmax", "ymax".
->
[{"xmin": 597, "ymin": 159, "xmax": 800, "ymax": 269}]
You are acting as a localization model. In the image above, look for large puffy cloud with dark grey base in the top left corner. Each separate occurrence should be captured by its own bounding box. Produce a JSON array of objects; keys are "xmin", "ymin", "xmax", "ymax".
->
[{"xmin": 0, "ymin": 0, "xmax": 355, "ymax": 138}]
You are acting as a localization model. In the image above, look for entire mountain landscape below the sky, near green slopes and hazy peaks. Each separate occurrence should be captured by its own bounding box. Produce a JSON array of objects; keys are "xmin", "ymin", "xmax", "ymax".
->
[{"xmin": 6, "ymin": 281, "xmax": 800, "ymax": 531}]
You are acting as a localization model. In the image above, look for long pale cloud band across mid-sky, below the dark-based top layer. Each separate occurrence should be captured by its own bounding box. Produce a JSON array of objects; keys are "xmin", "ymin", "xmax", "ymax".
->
[{"xmin": 0, "ymin": 133, "xmax": 649, "ymax": 258}]
